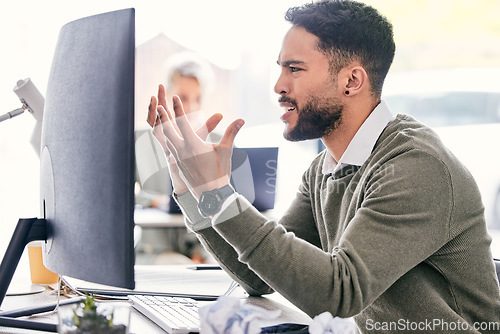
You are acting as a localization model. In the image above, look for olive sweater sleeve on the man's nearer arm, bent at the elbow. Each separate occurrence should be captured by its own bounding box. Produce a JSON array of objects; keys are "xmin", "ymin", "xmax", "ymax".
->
[{"xmin": 213, "ymin": 152, "xmax": 452, "ymax": 317}]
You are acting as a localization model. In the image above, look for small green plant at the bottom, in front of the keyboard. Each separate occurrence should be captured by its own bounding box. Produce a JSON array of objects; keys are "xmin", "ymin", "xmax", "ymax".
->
[{"xmin": 70, "ymin": 296, "xmax": 127, "ymax": 334}]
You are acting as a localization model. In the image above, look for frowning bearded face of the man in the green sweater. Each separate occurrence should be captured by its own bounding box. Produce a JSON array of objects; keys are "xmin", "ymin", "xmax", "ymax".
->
[{"xmin": 274, "ymin": 26, "xmax": 343, "ymax": 141}]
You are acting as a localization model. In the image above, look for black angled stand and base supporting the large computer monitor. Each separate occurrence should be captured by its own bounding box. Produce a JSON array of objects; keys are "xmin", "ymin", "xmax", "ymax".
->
[{"xmin": 0, "ymin": 218, "xmax": 57, "ymax": 333}]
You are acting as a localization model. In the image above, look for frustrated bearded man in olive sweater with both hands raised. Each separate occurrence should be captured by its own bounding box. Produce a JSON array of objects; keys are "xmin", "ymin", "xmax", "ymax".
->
[{"xmin": 148, "ymin": 0, "xmax": 500, "ymax": 333}]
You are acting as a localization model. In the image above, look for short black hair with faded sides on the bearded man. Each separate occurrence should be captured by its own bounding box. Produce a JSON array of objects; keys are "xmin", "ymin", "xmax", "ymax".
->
[{"xmin": 285, "ymin": 0, "xmax": 396, "ymax": 96}]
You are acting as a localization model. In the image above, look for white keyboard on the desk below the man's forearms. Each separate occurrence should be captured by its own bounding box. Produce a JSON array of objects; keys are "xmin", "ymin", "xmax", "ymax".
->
[{"xmin": 128, "ymin": 295, "xmax": 200, "ymax": 334}]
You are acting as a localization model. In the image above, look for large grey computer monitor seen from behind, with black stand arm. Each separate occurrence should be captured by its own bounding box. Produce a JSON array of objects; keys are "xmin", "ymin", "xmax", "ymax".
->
[{"xmin": 0, "ymin": 9, "xmax": 135, "ymax": 332}]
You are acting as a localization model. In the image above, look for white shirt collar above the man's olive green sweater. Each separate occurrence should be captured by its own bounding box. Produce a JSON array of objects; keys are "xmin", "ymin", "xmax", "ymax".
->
[{"xmin": 322, "ymin": 101, "xmax": 394, "ymax": 175}]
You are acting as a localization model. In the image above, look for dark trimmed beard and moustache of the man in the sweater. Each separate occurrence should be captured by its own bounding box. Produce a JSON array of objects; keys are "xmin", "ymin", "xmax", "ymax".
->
[{"xmin": 279, "ymin": 96, "xmax": 344, "ymax": 141}]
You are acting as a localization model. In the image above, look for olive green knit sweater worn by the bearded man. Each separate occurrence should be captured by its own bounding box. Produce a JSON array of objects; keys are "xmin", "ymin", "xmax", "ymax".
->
[{"xmin": 178, "ymin": 115, "xmax": 500, "ymax": 333}]
